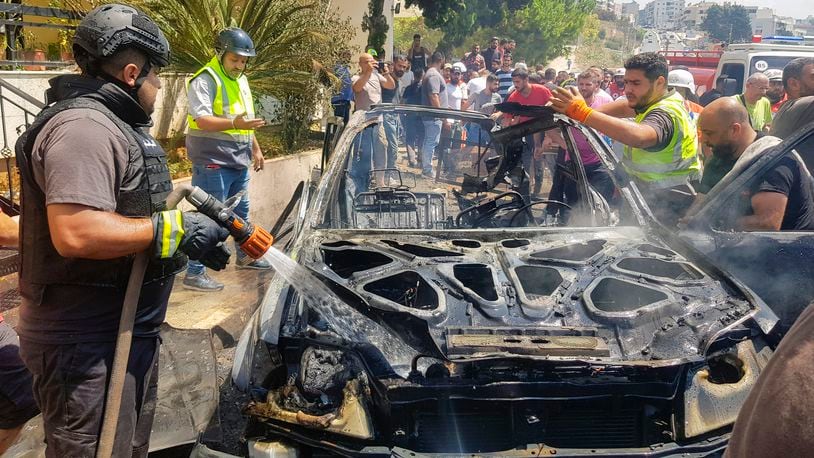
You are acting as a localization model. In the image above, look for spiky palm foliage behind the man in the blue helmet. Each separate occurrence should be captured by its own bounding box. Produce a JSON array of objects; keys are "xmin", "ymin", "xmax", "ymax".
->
[{"xmin": 135, "ymin": 0, "xmax": 355, "ymax": 149}]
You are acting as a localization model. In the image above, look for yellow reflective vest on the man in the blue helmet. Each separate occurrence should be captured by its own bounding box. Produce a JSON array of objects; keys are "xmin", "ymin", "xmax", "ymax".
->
[{"xmin": 187, "ymin": 57, "xmax": 254, "ymax": 143}]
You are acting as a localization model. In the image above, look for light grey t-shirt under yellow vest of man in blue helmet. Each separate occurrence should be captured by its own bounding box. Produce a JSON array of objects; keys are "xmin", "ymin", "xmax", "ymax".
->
[{"xmin": 186, "ymin": 72, "xmax": 252, "ymax": 169}]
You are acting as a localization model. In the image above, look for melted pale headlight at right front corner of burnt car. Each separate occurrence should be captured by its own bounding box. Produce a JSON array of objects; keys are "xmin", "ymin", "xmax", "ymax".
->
[{"xmin": 683, "ymin": 340, "xmax": 772, "ymax": 439}]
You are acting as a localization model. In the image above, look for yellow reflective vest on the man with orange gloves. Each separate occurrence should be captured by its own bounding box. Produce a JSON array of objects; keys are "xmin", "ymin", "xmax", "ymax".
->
[{"xmin": 622, "ymin": 92, "xmax": 701, "ymax": 189}]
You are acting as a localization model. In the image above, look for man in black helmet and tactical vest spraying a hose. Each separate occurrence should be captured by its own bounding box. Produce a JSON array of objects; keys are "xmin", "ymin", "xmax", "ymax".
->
[{"xmin": 16, "ymin": 4, "xmax": 229, "ymax": 458}]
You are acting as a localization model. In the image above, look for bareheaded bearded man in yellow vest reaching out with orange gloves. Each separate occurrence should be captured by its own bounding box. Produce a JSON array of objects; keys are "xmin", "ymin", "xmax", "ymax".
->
[{"xmin": 551, "ymin": 53, "xmax": 701, "ymax": 225}]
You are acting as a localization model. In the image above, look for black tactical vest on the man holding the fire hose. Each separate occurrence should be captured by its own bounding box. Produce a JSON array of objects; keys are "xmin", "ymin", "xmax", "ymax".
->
[{"xmin": 16, "ymin": 97, "xmax": 187, "ymax": 305}]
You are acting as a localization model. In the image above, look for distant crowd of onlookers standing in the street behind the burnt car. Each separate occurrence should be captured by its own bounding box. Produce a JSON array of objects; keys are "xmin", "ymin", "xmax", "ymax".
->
[{"xmin": 342, "ymin": 35, "xmax": 624, "ymax": 198}]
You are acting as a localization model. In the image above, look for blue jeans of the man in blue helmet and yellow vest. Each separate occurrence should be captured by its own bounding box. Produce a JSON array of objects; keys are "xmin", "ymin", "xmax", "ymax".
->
[{"xmin": 187, "ymin": 165, "xmax": 249, "ymax": 275}]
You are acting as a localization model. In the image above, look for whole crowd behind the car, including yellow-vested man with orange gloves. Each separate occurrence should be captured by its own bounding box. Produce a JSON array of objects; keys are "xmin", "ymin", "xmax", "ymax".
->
[{"xmin": 338, "ymin": 30, "xmax": 814, "ymax": 230}]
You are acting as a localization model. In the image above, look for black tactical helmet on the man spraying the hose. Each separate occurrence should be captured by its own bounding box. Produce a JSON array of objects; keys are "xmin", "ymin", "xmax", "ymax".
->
[{"xmin": 73, "ymin": 3, "xmax": 170, "ymax": 67}]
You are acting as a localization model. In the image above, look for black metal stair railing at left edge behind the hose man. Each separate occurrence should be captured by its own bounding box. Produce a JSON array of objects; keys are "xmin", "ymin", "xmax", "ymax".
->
[{"xmin": 0, "ymin": 78, "xmax": 45, "ymax": 210}]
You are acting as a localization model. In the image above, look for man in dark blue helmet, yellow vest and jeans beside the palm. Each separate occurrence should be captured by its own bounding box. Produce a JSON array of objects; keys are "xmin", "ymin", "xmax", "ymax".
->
[{"xmin": 183, "ymin": 27, "xmax": 271, "ymax": 291}]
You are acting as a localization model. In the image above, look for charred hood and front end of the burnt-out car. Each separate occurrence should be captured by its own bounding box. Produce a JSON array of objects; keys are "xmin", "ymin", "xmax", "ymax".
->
[{"xmin": 242, "ymin": 228, "xmax": 771, "ymax": 456}]
